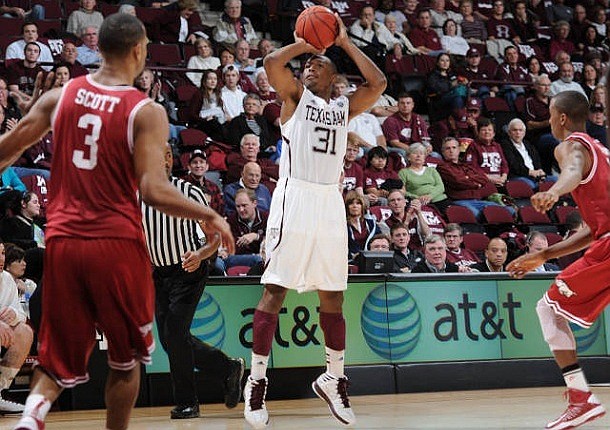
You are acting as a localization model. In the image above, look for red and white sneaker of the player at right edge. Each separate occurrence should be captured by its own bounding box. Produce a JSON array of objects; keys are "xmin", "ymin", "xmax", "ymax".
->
[{"xmin": 545, "ymin": 388, "xmax": 606, "ymax": 430}]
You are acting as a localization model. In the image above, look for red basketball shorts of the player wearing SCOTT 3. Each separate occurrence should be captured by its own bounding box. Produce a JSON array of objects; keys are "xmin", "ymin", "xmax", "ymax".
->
[{"xmin": 38, "ymin": 237, "xmax": 155, "ymax": 387}]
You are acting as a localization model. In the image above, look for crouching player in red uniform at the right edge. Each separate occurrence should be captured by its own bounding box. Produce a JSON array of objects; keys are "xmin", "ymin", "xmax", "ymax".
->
[{"xmin": 507, "ymin": 91, "xmax": 610, "ymax": 429}]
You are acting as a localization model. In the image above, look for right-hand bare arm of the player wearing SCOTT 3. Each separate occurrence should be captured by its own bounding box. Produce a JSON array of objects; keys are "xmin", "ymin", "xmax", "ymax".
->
[{"xmin": 134, "ymin": 103, "xmax": 235, "ymax": 254}]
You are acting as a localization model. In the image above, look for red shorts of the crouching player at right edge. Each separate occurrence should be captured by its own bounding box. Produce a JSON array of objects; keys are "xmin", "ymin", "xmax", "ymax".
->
[{"xmin": 544, "ymin": 237, "xmax": 610, "ymax": 328}]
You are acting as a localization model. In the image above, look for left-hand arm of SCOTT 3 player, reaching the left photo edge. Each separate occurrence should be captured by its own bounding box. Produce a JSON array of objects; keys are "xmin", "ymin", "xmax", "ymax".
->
[{"xmin": 0, "ymin": 89, "xmax": 61, "ymax": 172}]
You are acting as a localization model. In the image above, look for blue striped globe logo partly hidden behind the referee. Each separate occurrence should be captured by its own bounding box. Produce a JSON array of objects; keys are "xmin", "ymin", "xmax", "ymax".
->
[{"xmin": 191, "ymin": 292, "xmax": 226, "ymax": 349}]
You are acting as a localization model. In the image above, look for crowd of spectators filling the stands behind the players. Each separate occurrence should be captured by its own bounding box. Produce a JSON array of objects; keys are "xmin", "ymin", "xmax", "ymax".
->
[{"xmin": 0, "ymin": 0, "xmax": 610, "ymax": 275}]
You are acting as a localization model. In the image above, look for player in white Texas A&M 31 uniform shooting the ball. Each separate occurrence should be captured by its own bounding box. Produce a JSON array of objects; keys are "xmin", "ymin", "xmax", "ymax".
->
[{"xmin": 244, "ymin": 10, "xmax": 386, "ymax": 429}]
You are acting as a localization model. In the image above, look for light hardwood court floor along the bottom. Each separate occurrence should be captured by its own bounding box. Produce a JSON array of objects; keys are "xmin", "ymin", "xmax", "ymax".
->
[{"xmin": 0, "ymin": 386, "xmax": 610, "ymax": 430}]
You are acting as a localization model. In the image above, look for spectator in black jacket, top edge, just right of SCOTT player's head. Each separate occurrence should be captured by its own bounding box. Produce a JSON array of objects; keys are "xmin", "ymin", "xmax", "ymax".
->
[{"xmin": 152, "ymin": 0, "xmax": 207, "ymax": 44}]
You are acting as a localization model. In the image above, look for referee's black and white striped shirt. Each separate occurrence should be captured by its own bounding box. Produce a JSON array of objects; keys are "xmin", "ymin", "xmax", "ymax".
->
[{"xmin": 142, "ymin": 176, "xmax": 208, "ymax": 267}]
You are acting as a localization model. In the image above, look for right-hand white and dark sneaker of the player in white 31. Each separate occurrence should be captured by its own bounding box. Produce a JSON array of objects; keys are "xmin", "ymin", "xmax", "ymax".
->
[{"xmin": 311, "ymin": 372, "xmax": 356, "ymax": 427}]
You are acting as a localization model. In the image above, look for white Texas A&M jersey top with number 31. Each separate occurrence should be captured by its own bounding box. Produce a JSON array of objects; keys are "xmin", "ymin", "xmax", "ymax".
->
[{"xmin": 280, "ymin": 88, "xmax": 349, "ymax": 184}]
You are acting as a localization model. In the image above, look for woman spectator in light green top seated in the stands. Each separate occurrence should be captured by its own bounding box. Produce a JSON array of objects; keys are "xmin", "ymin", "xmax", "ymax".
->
[{"xmin": 398, "ymin": 142, "xmax": 451, "ymax": 213}]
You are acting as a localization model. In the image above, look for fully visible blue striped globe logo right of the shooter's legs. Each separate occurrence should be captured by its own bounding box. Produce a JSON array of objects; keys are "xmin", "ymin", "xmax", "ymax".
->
[{"xmin": 360, "ymin": 284, "xmax": 421, "ymax": 360}]
